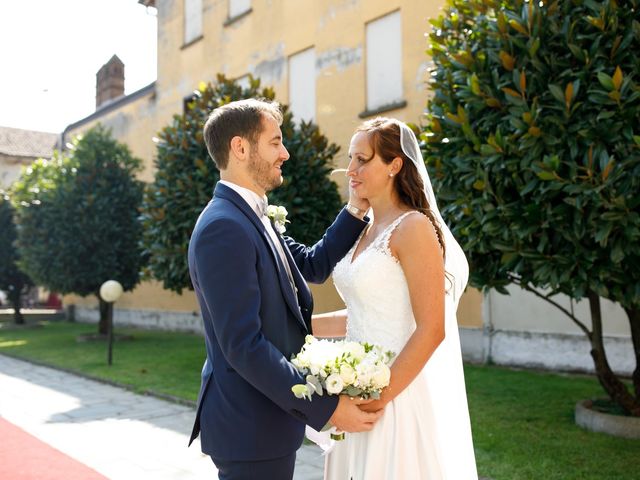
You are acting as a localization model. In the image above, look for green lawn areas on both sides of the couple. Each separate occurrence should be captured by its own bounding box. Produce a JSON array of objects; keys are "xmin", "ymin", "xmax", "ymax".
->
[{"xmin": 0, "ymin": 323, "xmax": 640, "ymax": 480}]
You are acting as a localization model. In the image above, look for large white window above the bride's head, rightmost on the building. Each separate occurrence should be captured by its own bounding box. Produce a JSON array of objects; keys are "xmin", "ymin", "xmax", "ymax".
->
[{"xmin": 366, "ymin": 11, "xmax": 404, "ymax": 111}]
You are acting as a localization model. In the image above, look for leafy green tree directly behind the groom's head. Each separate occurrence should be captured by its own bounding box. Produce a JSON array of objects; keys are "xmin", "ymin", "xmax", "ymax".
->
[{"xmin": 142, "ymin": 75, "xmax": 341, "ymax": 293}]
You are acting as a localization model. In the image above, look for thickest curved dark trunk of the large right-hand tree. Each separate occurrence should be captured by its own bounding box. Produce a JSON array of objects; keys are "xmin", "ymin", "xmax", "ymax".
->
[{"xmin": 589, "ymin": 291, "xmax": 640, "ymax": 417}]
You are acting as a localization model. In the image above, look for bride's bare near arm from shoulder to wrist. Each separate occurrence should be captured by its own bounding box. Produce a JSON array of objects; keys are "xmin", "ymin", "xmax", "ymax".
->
[{"xmin": 361, "ymin": 215, "xmax": 445, "ymax": 411}]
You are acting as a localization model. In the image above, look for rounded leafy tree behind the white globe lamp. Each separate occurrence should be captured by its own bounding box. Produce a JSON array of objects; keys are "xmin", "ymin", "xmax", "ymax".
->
[{"xmin": 12, "ymin": 125, "xmax": 144, "ymax": 333}]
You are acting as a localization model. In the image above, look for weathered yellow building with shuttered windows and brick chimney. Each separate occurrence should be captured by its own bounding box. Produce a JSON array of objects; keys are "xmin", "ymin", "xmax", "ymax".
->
[{"xmin": 63, "ymin": 0, "xmax": 482, "ymax": 334}]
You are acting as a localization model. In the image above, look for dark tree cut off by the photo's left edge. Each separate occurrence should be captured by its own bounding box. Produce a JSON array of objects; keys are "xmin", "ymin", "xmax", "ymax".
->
[{"xmin": 0, "ymin": 190, "xmax": 33, "ymax": 324}]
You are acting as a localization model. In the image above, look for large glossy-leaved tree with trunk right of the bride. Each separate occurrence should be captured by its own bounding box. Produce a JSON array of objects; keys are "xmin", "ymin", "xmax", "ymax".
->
[{"xmin": 423, "ymin": 0, "xmax": 640, "ymax": 416}]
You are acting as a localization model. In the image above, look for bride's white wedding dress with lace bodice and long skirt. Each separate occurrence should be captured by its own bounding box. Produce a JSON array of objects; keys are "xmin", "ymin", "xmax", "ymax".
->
[{"xmin": 325, "ymin": 211, "xmax": 477, "ymax": 480}]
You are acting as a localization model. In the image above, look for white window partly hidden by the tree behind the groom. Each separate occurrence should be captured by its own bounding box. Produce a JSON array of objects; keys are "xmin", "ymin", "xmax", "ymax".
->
[{"xmin": 289, "ymin": 48, "xmax": 316, "ymax": 121}]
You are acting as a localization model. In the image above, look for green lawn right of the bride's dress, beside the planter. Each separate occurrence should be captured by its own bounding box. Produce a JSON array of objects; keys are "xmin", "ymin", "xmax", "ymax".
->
[{"xmin": 465, "ymin": 366, "xmax": 640, "ymax": 480}]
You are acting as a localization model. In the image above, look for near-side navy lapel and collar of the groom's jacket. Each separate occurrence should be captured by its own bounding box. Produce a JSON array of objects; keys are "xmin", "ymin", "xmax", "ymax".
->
[{"xmin": 213, "ymin": 183, "xmax": 308, "ymax": 331}]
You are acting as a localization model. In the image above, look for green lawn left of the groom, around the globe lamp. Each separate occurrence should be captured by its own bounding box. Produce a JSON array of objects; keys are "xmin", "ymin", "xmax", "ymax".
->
[{"xmin": 0, "ymin": 322, "xmax": 206, "ymax": 401}]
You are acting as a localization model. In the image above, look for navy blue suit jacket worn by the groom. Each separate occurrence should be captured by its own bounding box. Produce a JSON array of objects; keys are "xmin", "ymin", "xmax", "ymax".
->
[{"xmin": 189, "ymin": 184, "xmax": 366, "ymax": 461}]
